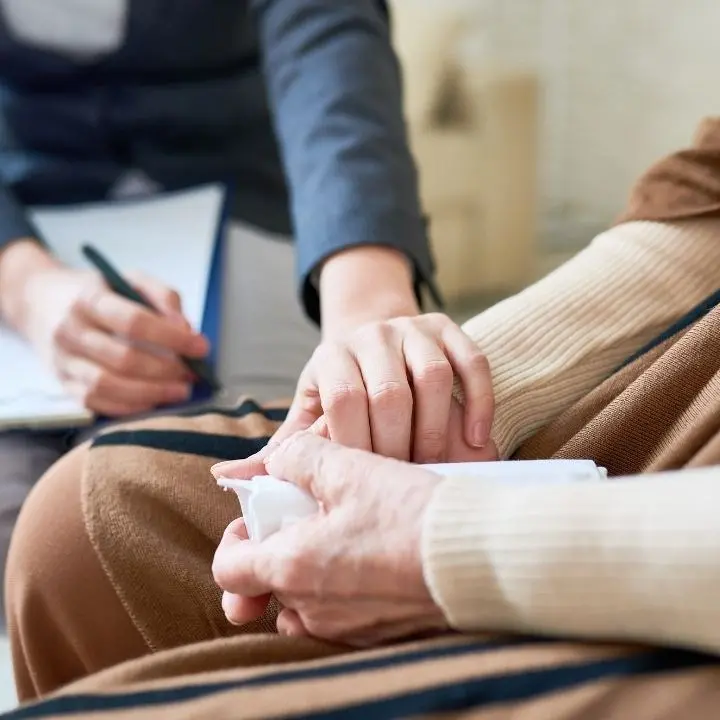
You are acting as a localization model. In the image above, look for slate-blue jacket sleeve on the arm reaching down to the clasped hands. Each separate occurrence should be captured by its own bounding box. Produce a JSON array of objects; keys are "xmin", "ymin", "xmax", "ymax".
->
[{"xmin": 251, "ymin": 0, "xmax": 433, "ymax": 320}]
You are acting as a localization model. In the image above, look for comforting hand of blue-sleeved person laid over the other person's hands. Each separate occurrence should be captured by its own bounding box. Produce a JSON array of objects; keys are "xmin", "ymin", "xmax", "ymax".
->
[{"xmin": 256, "ymin": 314, "xmax": 494, "ymax": 463}]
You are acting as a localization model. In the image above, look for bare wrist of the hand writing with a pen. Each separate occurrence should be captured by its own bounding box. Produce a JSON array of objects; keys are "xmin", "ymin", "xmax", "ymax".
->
[{"xmin": 0, "ymin": 238, "xmax": 58, "ymax": 332}]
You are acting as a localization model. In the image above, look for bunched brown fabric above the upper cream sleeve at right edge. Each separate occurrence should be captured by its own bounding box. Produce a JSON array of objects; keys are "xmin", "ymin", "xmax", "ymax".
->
[{"xmin": 618, "ymin": 117, "xmax": 720, "ymax": 223}]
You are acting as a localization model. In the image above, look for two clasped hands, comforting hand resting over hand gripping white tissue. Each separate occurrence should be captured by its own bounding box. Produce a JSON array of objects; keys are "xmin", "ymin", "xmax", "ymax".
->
[{"xmin": 213, "ymin": 315, "xmax": 497, "ymax": 645}]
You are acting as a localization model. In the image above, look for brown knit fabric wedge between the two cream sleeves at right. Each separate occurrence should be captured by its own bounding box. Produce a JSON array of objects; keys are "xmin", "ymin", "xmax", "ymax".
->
[{"xmin": 516, "ymin": 308, "xmax": 720, "ymax": 475}]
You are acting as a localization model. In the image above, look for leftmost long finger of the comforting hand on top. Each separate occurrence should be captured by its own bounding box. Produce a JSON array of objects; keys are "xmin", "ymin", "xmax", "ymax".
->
[{"xmin": 315, "ymin": 345, "xmax": 373, "ymax": 450}]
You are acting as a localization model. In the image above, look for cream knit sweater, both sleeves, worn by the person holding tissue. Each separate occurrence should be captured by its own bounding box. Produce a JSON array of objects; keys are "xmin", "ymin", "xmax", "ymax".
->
[{"xmin": 423, "ymin": 219, "xmax": 720, "ymax": 652}]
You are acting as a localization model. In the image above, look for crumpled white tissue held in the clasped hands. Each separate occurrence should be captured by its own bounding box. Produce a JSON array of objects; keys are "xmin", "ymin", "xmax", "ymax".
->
[{"xmin": 217, "ymin": 460, "xmax": 607, "ymax": 542}]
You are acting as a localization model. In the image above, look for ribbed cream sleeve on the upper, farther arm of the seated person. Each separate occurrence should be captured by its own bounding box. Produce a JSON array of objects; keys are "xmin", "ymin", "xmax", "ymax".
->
[{"xmin": 456, "ymin": 219, "xmax": 720, "ymax": 457}]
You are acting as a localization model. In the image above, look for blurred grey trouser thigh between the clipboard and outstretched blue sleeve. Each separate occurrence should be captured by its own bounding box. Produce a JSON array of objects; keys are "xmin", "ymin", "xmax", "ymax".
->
[{"xmin": 219, "ymin": 224, "xmax": 320, "ymax": 401}]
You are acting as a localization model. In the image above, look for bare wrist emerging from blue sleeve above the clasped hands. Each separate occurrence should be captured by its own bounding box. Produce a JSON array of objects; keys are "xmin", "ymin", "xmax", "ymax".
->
[{"xmin": 320, "ymin": 246, "xmax": 420, "ymax": 337}]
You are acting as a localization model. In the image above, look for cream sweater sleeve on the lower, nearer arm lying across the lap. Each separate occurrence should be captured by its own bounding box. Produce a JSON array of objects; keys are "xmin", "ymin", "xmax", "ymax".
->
[{"xmin": 423, "ymin": 467, "xmax": 720, "ymax": 652}]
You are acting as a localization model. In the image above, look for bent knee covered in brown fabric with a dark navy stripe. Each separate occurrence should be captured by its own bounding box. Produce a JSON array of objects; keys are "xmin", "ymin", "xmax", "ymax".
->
[{"xmin": 7, "ymin": 402, "xmax": 284, "ymax": 698}]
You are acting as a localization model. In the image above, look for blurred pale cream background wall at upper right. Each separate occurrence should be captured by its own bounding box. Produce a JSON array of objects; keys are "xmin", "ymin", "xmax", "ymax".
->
[{"xmin": 394, "ymin": 0, "xmax": 720, "ymax": 304}]
